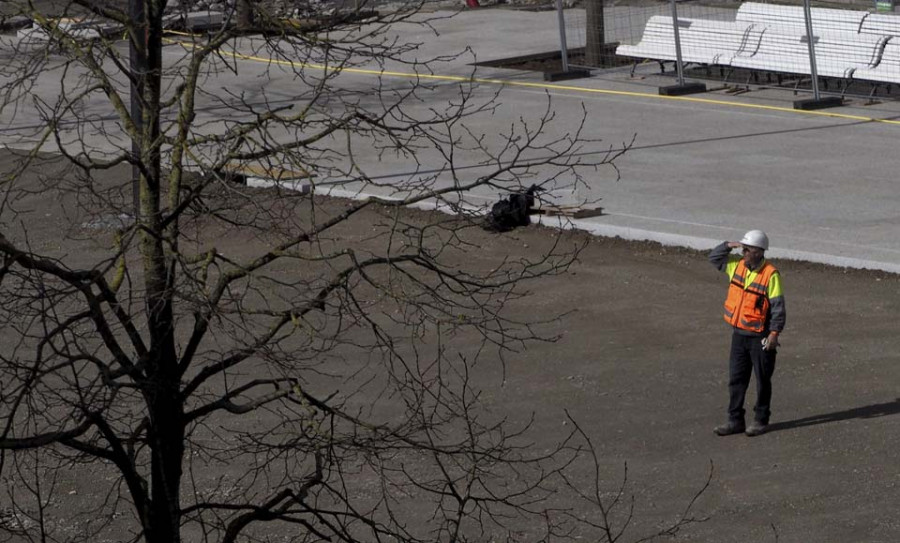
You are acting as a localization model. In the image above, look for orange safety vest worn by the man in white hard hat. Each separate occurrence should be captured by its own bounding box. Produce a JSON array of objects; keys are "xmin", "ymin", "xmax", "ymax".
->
[{"xmin": 724, "ymin": 260, "xmax": 778, "ymax": 332}]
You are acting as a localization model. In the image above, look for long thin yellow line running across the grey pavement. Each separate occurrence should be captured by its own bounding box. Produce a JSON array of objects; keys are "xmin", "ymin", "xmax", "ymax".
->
[{"xmin": 160, "ymin": 32, "xmax": 900, "ymax": 125}]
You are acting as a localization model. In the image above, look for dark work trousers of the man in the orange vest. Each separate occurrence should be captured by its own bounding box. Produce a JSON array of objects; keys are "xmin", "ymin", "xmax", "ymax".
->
[{"xmin": 728, "ymin": 332, "xmax": 776, "ymax": 424}]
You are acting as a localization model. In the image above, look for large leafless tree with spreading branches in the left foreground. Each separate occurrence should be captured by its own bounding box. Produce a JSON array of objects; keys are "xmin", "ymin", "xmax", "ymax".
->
[{"xmin": 0, "ymin": 0, "xmax": 708, "ymax": 543}]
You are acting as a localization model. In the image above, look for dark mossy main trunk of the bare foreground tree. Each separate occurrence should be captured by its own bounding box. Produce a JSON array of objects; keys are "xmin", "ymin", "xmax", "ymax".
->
[{"xmin": 132, "ymin": 0, "xmax": 184, "ymax": 543}]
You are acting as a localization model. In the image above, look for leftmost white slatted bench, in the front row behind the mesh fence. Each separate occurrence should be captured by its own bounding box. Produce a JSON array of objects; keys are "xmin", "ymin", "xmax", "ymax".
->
[{"xmin": 616, "ymin": 15, "xmax": 754, "ymax": 65}]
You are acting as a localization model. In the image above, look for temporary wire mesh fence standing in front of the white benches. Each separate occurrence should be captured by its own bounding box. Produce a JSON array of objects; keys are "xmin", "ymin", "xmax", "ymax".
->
[{"xmin": 566, "ymin": 0, "xmax": 900, "ymax": 99}]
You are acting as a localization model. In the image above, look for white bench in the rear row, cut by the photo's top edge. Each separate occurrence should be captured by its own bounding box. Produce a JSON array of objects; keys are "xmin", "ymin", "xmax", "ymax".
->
[{"xmin": 735, "ymin": 2, "xmax": 870, "ymax": 35}]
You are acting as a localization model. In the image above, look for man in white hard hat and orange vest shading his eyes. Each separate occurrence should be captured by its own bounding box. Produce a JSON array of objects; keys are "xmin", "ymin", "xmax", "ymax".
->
[{"xmin": 709, "ymin": 230, "xmax": 786, "ymax": 436}]
